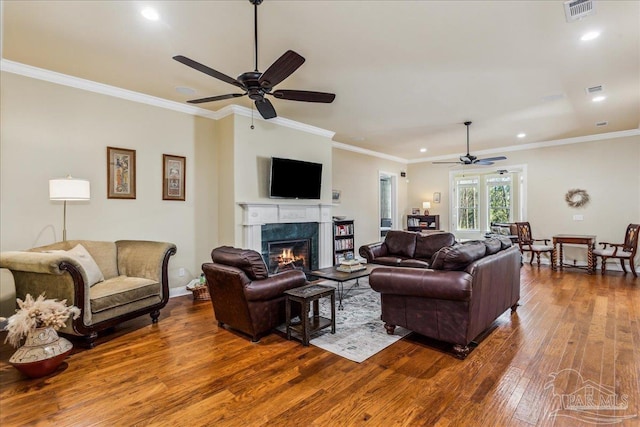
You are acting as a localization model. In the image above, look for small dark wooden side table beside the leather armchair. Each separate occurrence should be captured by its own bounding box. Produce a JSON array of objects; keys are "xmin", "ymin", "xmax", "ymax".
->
[{"xmin": 284, "ymin": 284, "xmax": 336, "ymax": 346}]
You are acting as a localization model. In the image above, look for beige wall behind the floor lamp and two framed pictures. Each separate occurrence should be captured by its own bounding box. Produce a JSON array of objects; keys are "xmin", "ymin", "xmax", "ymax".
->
[{"xmin": 0, "ymin": 73, "xmax": 218, "ymax": 287}]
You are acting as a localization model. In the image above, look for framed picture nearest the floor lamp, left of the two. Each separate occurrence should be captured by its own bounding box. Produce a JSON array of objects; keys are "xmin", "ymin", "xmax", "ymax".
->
[{"xmin": 107, "ymin": 147, "xmax": 136, "ymax": 199}]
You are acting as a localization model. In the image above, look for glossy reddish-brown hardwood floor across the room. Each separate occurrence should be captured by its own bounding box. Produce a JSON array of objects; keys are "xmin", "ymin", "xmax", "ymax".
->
[{"xmin": 0, "ymin": 264, "xmax": 640, "ymax": 427}]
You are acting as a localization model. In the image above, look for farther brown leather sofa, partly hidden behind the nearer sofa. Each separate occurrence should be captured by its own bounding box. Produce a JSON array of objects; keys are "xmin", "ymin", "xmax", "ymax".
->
[{"xmin": 359, "ymin": 230, "xmax": 456, "ymax": 268}]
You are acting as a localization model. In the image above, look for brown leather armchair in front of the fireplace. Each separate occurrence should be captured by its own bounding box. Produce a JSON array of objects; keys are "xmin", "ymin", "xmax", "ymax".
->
[{"xmin": 202, "ymin": 246, "xmax": 307, "ymax": 342}]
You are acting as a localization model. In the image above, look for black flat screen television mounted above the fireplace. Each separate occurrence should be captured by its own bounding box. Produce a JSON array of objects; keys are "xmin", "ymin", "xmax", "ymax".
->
[{"xmin": 269, "ymin": 157, "xmax": 322, "ymax": 199}]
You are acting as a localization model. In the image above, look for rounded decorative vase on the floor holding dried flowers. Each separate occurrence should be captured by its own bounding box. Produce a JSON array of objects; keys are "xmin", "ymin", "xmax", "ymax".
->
[{"xmin": 9, "ymin": 327, "xmax": 73, "ymax": 378}]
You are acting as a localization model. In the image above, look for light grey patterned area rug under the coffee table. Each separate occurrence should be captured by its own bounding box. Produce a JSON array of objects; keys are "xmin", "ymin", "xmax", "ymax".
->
[{"xmin": 282, "ymin": 278, "xmax": 411, "ymax": 363}]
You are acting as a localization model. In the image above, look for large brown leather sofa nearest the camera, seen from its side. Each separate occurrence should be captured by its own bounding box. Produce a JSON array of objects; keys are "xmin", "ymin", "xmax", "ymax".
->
[{"xmin": 369, "ymin": 237, "xmax": 520, "ymax": 359}]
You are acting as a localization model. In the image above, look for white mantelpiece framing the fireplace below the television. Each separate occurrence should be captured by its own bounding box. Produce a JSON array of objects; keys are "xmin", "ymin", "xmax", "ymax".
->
[{"xmin": 240, "ymin": 202, "xmax": 333, "ymax": 268}]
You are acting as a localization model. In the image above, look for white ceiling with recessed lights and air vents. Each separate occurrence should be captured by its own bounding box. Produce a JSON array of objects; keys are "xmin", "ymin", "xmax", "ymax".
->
[{"xmin": 2, "ymin": 0, "xmax": 640, "ymax": 160}]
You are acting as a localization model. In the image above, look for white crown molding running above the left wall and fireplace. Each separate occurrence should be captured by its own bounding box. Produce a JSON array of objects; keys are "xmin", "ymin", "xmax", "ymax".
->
[{"xmin": 0, "ymin": 58, "xmax": 335, "ymax": 139}]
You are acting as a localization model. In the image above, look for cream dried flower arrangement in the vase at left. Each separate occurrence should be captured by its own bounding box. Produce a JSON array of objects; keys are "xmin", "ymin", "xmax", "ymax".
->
[{"xmin": 0, "ymin": 294, "xmax": 80, "ymax": 348}]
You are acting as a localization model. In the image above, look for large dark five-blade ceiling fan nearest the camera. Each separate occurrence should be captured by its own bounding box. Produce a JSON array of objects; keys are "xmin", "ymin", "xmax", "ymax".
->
[{"xmin": 173, "ymin": 0, "xmax": 336, "ymax": 119}]
